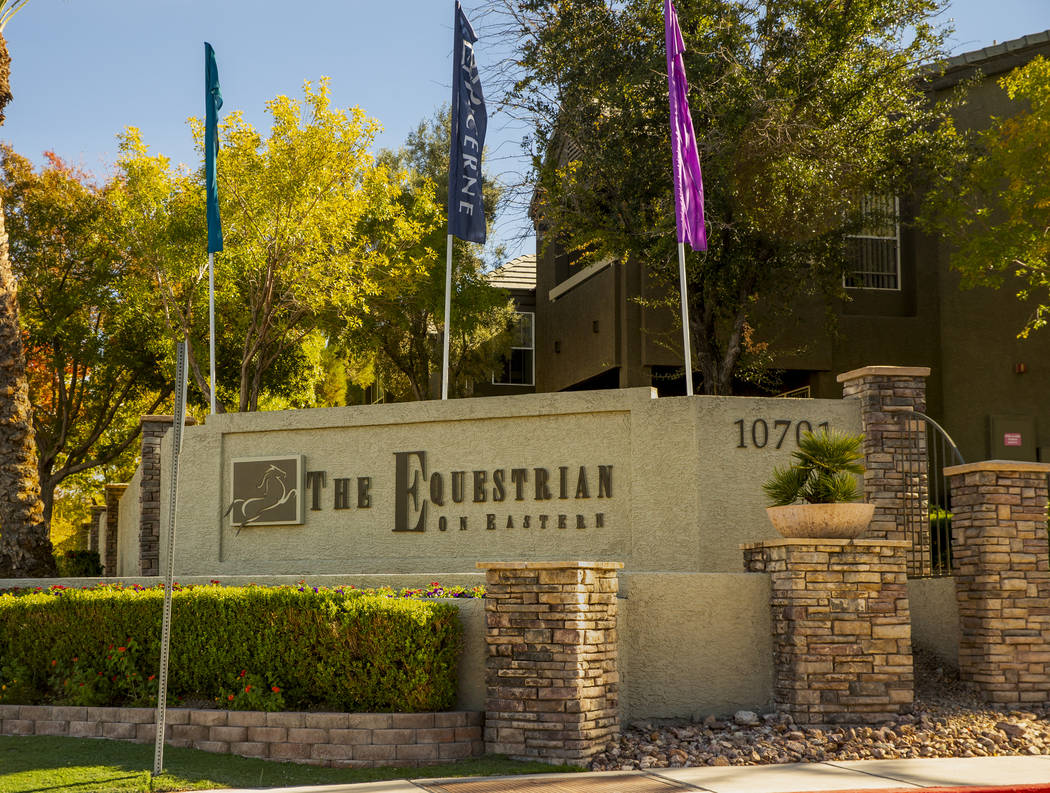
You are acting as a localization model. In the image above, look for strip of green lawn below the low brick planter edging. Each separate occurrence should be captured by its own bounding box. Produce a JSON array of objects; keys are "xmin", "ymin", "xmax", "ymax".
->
[{"xmin": 0, "ymin": 736, "xmax": 581, "ymax": 793}]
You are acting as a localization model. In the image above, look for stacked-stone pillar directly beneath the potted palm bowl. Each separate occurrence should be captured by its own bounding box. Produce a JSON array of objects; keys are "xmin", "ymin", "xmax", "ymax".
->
[{"xmin": 741, "ymin": 539, "xmax": 915, "ymax": 725}]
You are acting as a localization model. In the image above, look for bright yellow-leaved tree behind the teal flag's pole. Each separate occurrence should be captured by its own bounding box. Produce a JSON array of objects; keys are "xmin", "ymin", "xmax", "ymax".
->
[{"xmin": 119, "ymin": 79, "xmax": 431, "ymax": 411}]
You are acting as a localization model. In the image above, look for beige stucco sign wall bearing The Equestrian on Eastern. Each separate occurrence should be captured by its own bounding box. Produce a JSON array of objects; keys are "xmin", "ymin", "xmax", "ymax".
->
[{"xmin": 161, "ymin": 389, "xmax": 860, "ymax": 577}]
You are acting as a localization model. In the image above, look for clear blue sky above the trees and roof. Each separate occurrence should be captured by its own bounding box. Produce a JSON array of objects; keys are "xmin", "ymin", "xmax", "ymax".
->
[{"xmin": 0, "ymin": 0, "xmax": 1050, "ymax": 255}]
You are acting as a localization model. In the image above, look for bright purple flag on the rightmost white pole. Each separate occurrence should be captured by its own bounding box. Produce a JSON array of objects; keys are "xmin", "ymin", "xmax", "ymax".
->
[{"xmin": 664, "ymin": 0, "xmax": 708, "ymax": 251}]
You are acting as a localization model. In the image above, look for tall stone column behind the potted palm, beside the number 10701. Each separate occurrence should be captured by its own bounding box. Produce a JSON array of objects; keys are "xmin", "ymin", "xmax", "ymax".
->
[{"xmin": 837, "ymin": 367, "xmax": 929, "ymax": 542}]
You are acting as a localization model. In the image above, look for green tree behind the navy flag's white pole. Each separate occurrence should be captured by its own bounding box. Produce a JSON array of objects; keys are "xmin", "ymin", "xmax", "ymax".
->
[{"xmin": 345, "ymin": 108, "xmax": 511, "ymax": 399}]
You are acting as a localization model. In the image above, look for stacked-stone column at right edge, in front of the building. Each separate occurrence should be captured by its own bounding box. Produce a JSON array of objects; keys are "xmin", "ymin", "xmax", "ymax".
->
[{"xmin": 944, "ymin": 460, "xmax": 1050, "ymax": 707}]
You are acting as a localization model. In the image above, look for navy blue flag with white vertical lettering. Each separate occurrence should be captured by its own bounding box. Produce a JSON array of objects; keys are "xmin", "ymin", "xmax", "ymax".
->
[{"xmin": 448, "ymin": 2, "xmax": 488, "ymax": 243}]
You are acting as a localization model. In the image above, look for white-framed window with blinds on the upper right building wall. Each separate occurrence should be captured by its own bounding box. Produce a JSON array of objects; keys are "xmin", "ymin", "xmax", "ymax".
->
[{"xmin": 842, "ymin": 195, "xmax": 901, "ymax": 290}]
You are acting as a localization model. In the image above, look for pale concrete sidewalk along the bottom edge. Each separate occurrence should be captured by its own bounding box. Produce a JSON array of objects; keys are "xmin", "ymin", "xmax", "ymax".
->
[{"xmin": 197, "ymin": 755, "xmax": 1050, "ymax": 793}]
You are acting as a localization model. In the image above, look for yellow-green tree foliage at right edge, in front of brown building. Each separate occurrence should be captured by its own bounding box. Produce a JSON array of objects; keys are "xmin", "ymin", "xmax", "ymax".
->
[{"xmin": 924, "ymin": 56, "xmax": 1050, "ymax": 337}]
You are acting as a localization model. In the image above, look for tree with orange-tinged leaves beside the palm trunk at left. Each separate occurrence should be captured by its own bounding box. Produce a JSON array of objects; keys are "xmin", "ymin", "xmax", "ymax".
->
[{"xmin": 0, "ymin": 146, "xmax": 173, "ymax": 526}]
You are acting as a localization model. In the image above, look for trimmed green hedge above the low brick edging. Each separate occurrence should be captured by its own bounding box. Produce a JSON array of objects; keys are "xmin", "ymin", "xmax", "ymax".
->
[{"xmin": 0, "ymin": 586, "xmax": 462, "ymax": 712}]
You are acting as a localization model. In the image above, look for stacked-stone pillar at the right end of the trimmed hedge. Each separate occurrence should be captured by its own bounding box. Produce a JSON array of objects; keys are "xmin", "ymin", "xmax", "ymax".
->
[{"xmin": 478, "ymin": 562, "xmax": 624, "ymax": 764}]
